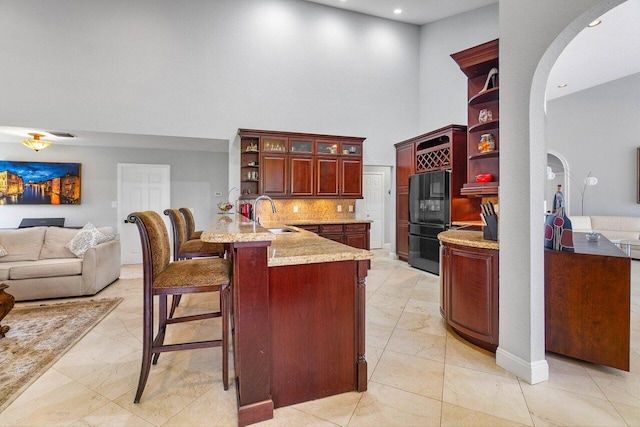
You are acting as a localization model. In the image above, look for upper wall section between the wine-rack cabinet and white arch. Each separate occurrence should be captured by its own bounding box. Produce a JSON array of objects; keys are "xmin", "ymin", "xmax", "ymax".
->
[{"xmin": 420, "ymin": 4, "xmax": 499, "ymax": 132}]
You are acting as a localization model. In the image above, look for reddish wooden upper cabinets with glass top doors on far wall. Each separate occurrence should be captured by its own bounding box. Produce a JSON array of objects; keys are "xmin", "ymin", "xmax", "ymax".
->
[{"xmin": 238, "ymin": 129, "xmax": 364, "ymax": 198}]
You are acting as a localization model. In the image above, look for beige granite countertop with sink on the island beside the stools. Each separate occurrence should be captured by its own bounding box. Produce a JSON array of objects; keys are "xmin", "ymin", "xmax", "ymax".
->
[{"xmin": 201, "ymin": 215, "xmax": 373, "ymax": 267}]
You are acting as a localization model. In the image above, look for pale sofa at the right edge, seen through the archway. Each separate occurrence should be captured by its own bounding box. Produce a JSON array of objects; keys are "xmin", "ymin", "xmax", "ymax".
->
[{"xmin": 569, "ymin": 215, "xmax": 640, "ymax": 259}]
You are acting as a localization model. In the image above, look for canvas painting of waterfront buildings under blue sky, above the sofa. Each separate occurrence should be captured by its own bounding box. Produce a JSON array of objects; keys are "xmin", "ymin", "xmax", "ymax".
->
[{"xmin": 0, "ymin": 160, "xmax": 81, "ymax": 205}]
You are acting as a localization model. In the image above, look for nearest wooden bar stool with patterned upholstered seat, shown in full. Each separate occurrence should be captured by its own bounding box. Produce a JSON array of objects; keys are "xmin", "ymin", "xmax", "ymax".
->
[{"xmin": 127, "ymin": 211, "xmax": 231, "ymax": 403}]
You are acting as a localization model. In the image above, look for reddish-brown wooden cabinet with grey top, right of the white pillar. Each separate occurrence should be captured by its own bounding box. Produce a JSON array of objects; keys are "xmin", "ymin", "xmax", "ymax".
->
[{"xmin": 544, "ymin": 233, "xmax": 631, "ymax": 371}]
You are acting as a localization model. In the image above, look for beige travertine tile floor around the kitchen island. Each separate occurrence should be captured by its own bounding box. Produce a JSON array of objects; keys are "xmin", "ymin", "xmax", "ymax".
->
[{"xmin": 0, "ymin": 251, "xmax": 640, "ymax": 427}]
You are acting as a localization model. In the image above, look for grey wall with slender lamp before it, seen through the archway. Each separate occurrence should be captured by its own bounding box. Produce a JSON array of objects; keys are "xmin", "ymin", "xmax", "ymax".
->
[{"xmin": 547, "ymin": 74, "xmax": 640, "ymax": 216}]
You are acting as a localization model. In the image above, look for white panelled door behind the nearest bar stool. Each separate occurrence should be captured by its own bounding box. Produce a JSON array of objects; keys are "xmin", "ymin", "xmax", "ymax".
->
[{"xmin": 118, "ymin": 163, "xmax": 171, "ymax": 264}]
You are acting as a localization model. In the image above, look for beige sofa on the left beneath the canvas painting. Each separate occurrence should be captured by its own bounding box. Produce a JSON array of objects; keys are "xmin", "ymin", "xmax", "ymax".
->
[{"xmin": 0, "ymin": 227, "xmax": 120, "ymax": 301}]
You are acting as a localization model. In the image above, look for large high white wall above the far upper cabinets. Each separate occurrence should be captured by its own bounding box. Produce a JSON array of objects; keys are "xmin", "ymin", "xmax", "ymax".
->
[{"xmin": 0, "ymin": 0, "xmax": 419, "ymax": 165}]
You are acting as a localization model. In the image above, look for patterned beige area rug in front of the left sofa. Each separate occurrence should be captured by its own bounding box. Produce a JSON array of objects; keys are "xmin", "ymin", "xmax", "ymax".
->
[{"xmin": 0, "ymin": 298, "xmax": 122, "ymax": 412}]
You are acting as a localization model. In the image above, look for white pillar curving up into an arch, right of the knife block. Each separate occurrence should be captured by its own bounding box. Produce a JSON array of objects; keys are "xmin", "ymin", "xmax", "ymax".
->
[{"xmin": 496, "ymin": 0, "xmax": 620, "ymax": 383}]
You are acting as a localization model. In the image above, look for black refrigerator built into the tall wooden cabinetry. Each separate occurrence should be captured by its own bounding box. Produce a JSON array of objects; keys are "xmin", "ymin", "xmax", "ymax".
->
[{"xmin": 409, "ymin": 170, "xmax": 451, "ymax": 274}]
